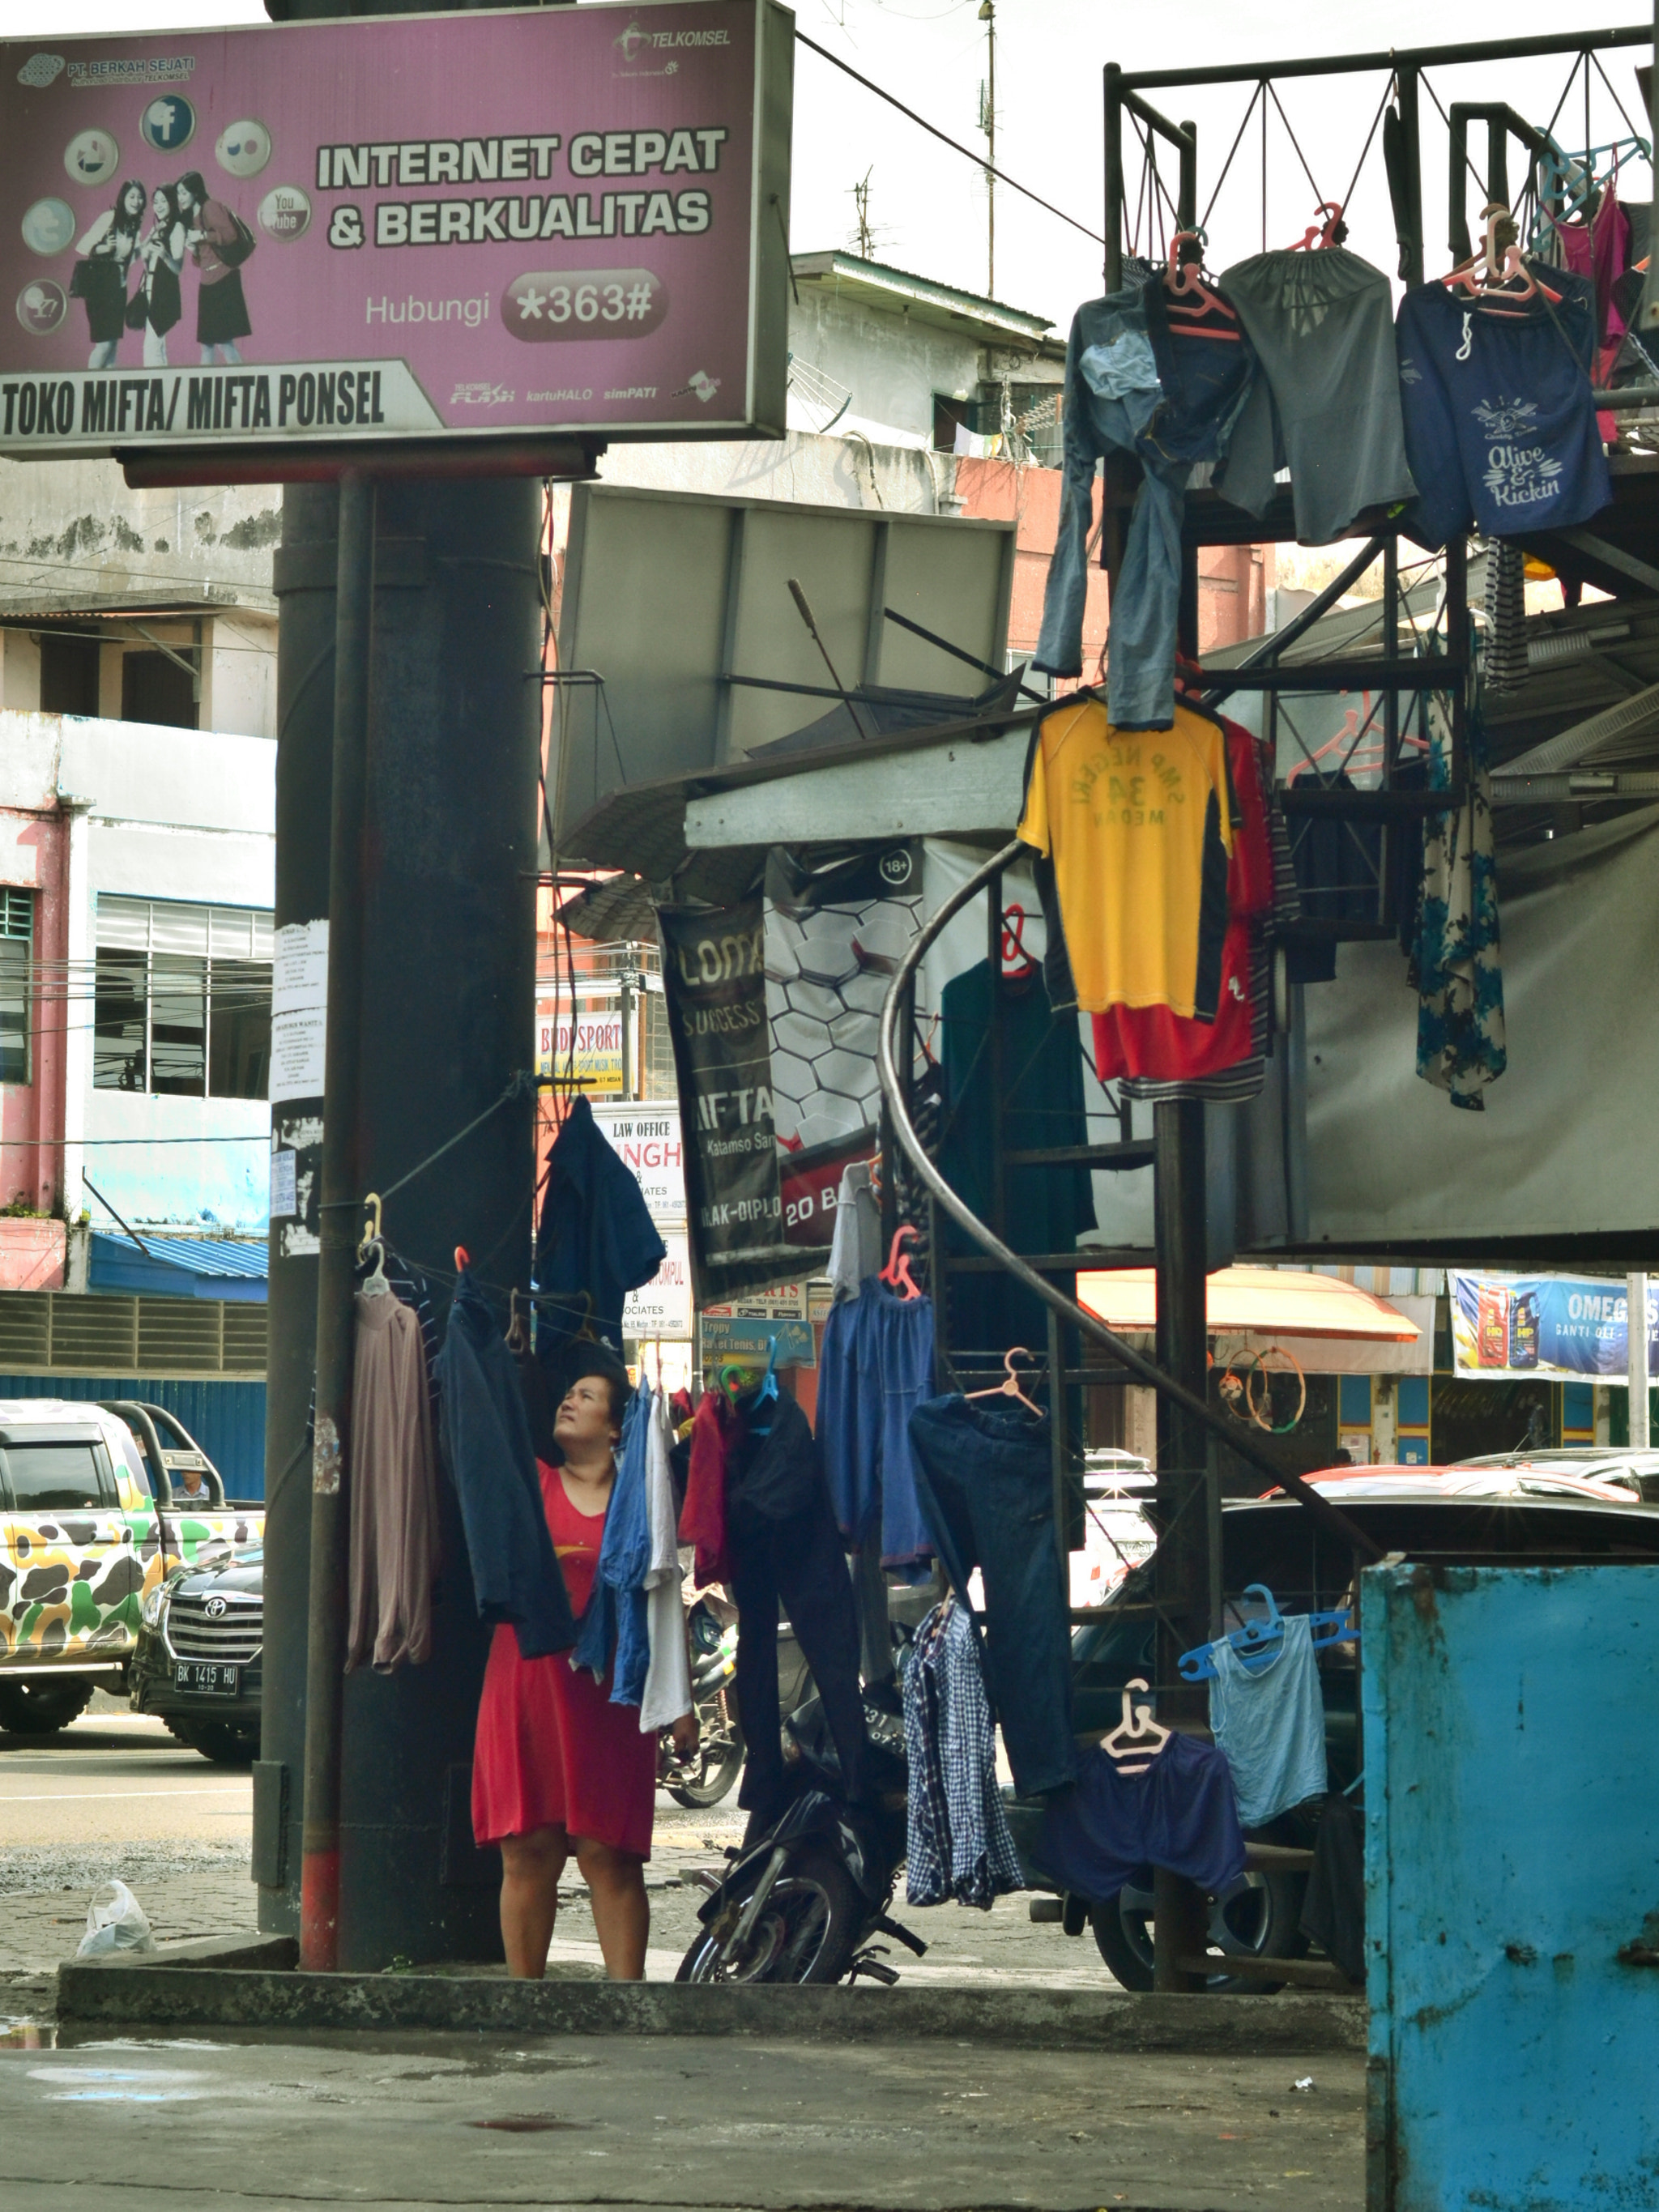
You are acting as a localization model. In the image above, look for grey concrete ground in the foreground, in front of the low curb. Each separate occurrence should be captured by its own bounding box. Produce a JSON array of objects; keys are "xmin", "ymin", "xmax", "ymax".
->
[{"xmin": 0, "ymin": 2026, "xmax": 1365, "ymax": 2212}]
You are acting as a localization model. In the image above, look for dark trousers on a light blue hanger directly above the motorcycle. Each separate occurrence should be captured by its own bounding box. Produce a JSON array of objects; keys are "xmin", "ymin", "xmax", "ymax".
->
[{"xmin": 726, "ymin": 1396, "xmax": 865, "ymax": 1821}]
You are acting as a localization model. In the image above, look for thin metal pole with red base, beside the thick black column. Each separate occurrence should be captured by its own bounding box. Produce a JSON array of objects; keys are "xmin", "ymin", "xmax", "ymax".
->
[{"xmin": 299, "ymin": 469, "xmax": 373, "ymax": 1973}]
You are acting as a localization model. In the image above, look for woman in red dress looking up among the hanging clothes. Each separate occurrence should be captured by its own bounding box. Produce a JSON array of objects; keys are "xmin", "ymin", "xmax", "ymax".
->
[{"xmin": 473, "ymin": 1361, "xmax": 697, "ymax": 1982}]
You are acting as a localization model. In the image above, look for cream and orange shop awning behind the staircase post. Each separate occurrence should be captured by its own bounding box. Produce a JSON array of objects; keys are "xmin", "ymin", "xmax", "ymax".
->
[{"xmin": 1077, "ymin": 1268, "xmax": 1433, "ymax": 1374}]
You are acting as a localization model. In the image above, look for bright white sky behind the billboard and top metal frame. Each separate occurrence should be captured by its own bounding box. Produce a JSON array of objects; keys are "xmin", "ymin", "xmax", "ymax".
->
[{"xmin": 0, "ymin": 0, "xmax": 1653, "ymax": 334}]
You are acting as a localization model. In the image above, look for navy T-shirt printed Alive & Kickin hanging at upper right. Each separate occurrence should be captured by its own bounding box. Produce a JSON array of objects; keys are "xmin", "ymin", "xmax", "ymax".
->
[{"xmin": 1396, "ymin": 261, "xmax": 1613, "ymax": 553}]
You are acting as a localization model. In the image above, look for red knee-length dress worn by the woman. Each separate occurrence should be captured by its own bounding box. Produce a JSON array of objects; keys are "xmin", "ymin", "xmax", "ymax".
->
[{"xmin": 473, "ymin": 1462, "xmax": 657, "ymax": 1858}]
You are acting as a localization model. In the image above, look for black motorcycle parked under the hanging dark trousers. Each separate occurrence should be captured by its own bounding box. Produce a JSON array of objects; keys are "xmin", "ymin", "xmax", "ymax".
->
[{"xmin": 675, "ymin": 1683, "xmax": 927, "ymax": 1984}]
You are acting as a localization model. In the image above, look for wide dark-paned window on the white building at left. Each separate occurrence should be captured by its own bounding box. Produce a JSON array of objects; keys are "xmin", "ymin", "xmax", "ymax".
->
[{"xmin": 93, "ymin": 896, "xmax": 272, "ymax": 1099}]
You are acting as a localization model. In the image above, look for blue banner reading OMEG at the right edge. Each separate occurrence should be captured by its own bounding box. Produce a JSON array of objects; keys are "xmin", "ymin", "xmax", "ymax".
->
[{"xmin": 1451, "ymin": 1268, "xmax": 1659, "ymax": 1383}]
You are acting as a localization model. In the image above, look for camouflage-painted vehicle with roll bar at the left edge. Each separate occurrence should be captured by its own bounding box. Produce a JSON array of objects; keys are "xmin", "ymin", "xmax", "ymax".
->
[{"xmin": 0, "ymin": 1398, "xmax": 266, "ymax": 1734}]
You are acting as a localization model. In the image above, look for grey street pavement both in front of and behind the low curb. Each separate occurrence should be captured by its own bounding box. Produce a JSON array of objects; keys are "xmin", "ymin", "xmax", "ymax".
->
[{"xmin": 0, "ymin": 1701, "xmax": 1365, "ymax": 2212}]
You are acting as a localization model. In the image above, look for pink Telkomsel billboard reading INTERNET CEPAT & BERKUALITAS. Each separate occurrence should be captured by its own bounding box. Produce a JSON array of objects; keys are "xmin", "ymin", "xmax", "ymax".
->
[{"xmin": 0, "ymin": 0, "xmax": 794, "ymax": 456}]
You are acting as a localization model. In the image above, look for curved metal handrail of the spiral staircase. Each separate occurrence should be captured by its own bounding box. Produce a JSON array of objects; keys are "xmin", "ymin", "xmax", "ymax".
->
[{"xmin": 876, "ymin": 838, "xmax": 1383, "ymax": 1562}]
